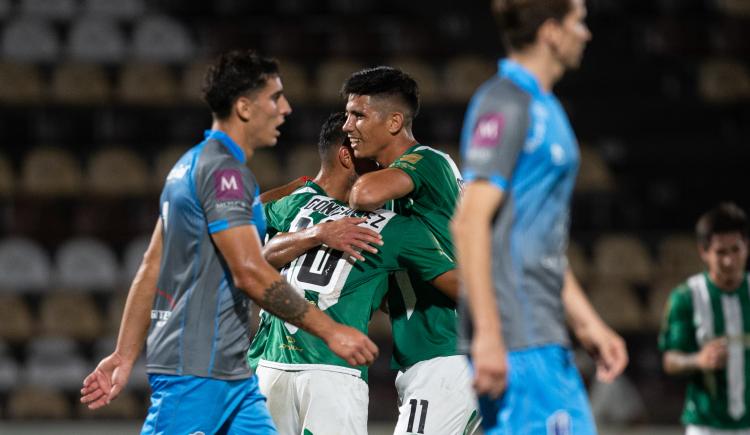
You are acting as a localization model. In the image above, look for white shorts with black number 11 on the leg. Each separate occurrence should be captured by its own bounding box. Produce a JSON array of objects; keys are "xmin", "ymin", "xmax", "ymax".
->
[{"xmin": 393, "ymin": 355, "xmax": 481, "ymax": 435}]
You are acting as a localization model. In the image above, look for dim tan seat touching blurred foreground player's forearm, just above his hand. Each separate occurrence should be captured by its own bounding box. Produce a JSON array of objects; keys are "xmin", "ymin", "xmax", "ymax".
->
[{"xmin": 589, "ymin": 278, "xmax": 645, "ymax": 332}]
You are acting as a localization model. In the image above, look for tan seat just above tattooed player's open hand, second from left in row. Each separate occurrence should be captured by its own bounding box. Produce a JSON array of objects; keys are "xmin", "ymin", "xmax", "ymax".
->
[{"xmin": 39, "ymin": 292, "xmax": 104, "ymax": 341}]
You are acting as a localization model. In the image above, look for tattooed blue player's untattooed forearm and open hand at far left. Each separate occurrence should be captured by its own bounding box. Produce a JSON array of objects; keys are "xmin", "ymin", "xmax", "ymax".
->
[{"xmin": 81, "ymin": 219, "xmax": 162, "ymax": 409}]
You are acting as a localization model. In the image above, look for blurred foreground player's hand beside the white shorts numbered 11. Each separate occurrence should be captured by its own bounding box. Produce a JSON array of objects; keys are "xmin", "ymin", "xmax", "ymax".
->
[{"xmin": 471, "ymin": 335, "xmax": 508, "ymax": 399}]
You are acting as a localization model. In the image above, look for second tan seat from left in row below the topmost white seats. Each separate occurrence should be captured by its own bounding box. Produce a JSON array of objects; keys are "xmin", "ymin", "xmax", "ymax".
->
[{"xmin": 51, "ymin": 63, "xmax": 111, "ymax": 104}]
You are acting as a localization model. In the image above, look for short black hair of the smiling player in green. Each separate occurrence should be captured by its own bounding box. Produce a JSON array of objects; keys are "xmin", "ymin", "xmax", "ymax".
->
[{"xmin": 341, "ymin": 66, "xmax": 419, "ymax": 121}]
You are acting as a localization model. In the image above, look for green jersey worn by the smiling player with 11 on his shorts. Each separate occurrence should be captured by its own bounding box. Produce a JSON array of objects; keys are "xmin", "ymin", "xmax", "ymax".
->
[{"xmin": 388, "ymin": 144, "xmax": 463, "ymax": 369}]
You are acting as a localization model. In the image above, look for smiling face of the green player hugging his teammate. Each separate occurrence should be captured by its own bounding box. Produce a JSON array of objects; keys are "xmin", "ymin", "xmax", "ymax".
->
[{"xmin": 343, "ymin": 95, "xmax": 393, "ymax": 159}]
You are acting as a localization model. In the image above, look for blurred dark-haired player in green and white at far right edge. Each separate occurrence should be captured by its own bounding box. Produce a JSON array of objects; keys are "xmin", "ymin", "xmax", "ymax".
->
[{"xmin": 659, "ymin": 203, "xmax": 750, "ymax": 435}]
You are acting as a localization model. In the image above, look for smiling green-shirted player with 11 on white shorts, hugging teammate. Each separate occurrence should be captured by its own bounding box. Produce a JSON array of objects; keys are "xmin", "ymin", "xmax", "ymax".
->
[{"xmin": 342, "ymin": 66, "xmax": 478, "ymax": 434}]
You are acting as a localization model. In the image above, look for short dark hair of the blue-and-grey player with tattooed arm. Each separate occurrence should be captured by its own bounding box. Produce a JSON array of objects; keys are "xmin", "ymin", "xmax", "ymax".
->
[{"xmin": 202, "ymin": 50, "xmax": 279, "ymax": 119}]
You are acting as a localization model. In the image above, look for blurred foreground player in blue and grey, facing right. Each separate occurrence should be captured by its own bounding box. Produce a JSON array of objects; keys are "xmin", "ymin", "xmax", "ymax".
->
[{"xmin": 452, "ymin": 0, "xmax": 627, "ymax": 435}]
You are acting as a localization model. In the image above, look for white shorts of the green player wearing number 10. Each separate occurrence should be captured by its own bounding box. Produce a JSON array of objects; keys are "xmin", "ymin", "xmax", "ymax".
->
[{"xmin": 255, "ymin": 366, "xmax": 369, "ymax": 435}]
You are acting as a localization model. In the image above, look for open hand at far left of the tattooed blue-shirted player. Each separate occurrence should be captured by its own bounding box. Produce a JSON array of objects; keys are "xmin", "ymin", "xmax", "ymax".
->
[{"xmin": 81, "ymin": 353, "xmax": 133, "ymax": 409}]
